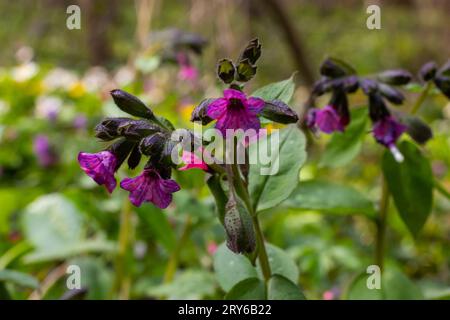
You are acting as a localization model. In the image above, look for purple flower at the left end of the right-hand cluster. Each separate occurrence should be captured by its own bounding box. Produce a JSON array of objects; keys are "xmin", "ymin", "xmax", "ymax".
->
[{"xmin": 306, "ymin": 106, "xmax": 345, "ymax": 133}]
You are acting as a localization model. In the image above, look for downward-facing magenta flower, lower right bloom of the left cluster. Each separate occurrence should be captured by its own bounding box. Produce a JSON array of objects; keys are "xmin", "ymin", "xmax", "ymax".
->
[{"xmin": 120, "ymin": 169, "xmax": 180, "ymax": 209}]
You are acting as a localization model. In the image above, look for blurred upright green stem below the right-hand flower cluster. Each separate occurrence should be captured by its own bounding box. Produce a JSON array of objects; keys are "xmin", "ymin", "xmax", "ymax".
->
[{"xmin": 375, "ymin": 177, "xmax": 389, "ymax": 270}]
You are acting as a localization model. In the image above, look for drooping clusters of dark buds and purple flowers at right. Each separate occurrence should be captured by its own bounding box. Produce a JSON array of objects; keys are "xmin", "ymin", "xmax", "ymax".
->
[{"xmin": 305, "ymin": 58, "xmax": 442, "ymax": 162}]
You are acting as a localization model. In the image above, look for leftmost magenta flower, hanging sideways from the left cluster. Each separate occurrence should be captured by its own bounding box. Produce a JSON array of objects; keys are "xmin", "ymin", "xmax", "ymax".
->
[{"xmin": 78, "ymin": 151, "xmax": 117, "ymax": 193}]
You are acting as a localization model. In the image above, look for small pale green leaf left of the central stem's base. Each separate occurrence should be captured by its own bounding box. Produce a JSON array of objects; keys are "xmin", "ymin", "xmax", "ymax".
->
[{"xmin": 214, "ymin": 244, "xmax": 257, "ymax": 291}]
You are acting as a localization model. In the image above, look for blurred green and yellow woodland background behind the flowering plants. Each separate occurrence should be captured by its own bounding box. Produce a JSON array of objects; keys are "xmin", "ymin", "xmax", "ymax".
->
[{"xmin": 0, "ymin": 0, "xmax": 450, "ymax": 299}]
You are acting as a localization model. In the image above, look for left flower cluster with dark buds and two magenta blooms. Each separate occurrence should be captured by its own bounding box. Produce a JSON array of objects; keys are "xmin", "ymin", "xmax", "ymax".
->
[{"xmin": 78, "ymin": 90, "xmax": 180, "ymax": 209}]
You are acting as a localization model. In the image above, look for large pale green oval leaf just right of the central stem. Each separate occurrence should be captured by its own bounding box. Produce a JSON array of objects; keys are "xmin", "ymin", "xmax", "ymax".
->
[{"xmin": 249, "ymin": 126, "xmax": 306, "ymax": 211}]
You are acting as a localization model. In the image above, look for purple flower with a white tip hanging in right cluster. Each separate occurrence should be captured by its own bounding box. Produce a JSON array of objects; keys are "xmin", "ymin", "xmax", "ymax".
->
[{"xmin": 372, "ymin": 116, "xmax": 406, "ymax": 162}]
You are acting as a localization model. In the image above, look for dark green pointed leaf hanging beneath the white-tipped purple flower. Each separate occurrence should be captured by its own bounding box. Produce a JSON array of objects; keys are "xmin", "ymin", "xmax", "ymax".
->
[{"xmin": 382, "ymin": 141, "xmax": 433, "ymax": 236}]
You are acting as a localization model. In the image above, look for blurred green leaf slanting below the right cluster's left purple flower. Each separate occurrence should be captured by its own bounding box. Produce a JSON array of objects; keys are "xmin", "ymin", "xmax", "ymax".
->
[{"xmin": 319, "ymin": 108, "xmax": 368, "ymax": 168}]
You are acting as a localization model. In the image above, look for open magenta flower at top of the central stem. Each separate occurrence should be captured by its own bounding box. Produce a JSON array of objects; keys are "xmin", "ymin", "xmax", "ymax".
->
[{"xmin": 207, "ymin": 89, "xmax": 265, "ymax": 136}]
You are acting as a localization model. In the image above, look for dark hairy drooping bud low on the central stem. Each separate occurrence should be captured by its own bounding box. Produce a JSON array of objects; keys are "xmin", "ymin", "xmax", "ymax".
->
[{"xmin": 224, "ymin": 197, "xmax": 256, "ymax": 253}]
